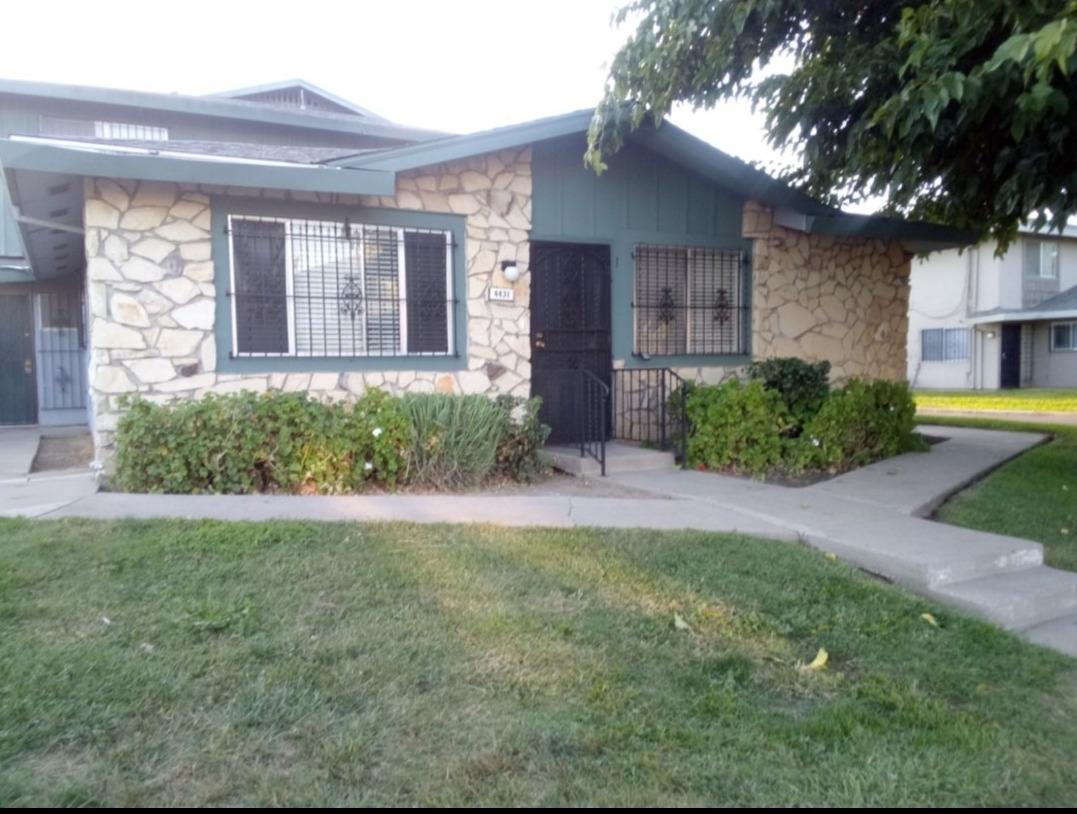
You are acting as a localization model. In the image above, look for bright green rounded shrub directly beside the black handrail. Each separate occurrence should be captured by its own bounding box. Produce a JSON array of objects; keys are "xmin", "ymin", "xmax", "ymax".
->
[{"xmin": 687, "ymin": 379, "xmax": 793, "ymax": 476}]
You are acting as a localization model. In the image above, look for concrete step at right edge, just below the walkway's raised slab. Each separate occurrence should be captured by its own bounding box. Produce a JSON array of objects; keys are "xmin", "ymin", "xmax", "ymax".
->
[{"xmin": 934, "ymin": 566, "xmax": 1077, "ymax": 630}]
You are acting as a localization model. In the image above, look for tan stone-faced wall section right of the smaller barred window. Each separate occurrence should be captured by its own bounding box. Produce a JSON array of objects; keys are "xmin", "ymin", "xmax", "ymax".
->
[{"xmin": 744, "ymin": 202, "xmax": 910, "ymax": 381}]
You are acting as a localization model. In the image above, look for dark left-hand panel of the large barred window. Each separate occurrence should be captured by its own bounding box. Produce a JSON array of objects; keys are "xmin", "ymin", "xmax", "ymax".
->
[{"xmin": 232, "ymin": 220, "xmax": 289, "ymax": 353}]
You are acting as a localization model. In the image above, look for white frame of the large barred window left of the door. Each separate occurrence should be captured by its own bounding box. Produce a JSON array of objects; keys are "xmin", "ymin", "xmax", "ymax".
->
[{"xmin": 227, "ymin": 213, "xmax": 457, "ymax": 360}]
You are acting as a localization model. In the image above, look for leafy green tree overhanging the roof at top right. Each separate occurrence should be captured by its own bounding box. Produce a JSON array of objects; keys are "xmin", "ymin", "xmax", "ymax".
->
[{"xmin": 586, "ymin": 0, "xmax": 1077, "ymax": 244}]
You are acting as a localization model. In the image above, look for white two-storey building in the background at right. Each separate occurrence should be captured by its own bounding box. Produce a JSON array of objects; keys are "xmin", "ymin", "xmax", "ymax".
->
[{"xmin": 908, "ymin": 226, "xmax": 1077, "ymax": 390}]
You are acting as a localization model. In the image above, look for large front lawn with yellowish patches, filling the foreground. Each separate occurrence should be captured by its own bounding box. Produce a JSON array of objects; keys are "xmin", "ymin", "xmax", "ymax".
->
[{"xmin": 0, "ymin": 520, "xmax": 1077, "ymax": 805}]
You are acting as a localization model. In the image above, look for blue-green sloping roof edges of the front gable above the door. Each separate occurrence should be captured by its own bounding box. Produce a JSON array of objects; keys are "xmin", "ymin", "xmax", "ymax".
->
[{"xmin": 328, "ymin": 109, "xmax": 979, "ymax": 252}]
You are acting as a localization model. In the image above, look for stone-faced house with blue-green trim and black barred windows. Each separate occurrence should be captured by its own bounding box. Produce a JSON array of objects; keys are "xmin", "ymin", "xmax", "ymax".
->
[{"xmin": 0, "ymin": 81, "xmax": 969, "ymax": 464}]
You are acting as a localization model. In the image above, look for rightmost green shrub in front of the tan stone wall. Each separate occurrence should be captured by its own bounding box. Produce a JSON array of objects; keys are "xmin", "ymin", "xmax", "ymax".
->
[{"xmin": 792, "ymin": 379, "xmax": 924, "ymax": 473}]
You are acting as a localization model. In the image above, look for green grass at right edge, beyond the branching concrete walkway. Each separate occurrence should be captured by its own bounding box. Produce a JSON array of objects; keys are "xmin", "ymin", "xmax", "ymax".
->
[{"xmin": 927, "ymin": 417, "xmax": 1077, "ymax": 571}]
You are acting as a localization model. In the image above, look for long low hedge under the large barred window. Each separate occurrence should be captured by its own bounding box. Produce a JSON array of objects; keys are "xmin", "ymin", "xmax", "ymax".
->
[{"xmin": 112, "ymin": 390, "xmax": 549, "ymax": 494}]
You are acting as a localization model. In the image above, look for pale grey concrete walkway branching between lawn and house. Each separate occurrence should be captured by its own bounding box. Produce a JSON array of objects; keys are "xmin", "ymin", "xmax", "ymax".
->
[{"xmin": 6, "ymin": 426, "xmax": 1077, "ymax": 656}]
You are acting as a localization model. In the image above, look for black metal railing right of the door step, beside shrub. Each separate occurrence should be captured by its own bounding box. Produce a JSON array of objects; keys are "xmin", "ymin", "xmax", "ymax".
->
[{"xmin": 612, "ymin": 367, "xmax": 688, "ymax": 465}]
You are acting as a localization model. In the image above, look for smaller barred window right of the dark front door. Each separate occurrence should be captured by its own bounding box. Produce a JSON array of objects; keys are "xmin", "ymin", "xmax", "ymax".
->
[{"xmin": 632, "ymin": 244, "xmax": 750, "ymax": 355}]
